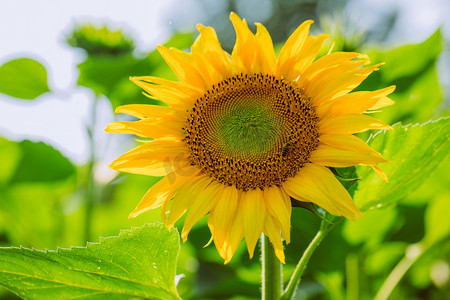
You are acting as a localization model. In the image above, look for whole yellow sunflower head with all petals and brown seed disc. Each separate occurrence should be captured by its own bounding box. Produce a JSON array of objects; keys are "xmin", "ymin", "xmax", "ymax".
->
[{"xmin": 106, "ymin": 13, "xmax": 395, "ymax": 263}]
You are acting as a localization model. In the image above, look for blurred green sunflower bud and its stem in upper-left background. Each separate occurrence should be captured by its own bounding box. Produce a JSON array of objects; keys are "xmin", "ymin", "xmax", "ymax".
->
[{"xmin": 67, "ymin": 23, "xmax": 137, "ymax": 242}]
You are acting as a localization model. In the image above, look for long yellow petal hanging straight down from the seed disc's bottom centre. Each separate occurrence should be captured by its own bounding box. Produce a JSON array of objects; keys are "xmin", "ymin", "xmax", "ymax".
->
[{"xmin": 240, "ymin": 188, "xmax": 266, "ymax": 258}]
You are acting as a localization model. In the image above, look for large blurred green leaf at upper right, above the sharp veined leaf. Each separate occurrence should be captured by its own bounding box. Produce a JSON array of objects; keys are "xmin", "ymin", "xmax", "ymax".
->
[{"xmin": 357, "ymin": 30, "xmax": 442, "ymax": 124}]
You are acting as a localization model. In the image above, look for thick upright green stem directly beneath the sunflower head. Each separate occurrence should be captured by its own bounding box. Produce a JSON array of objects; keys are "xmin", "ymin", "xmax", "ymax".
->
[{"xmin": 261, "ymin": 234, "xmax": 283, "ymax": 300}]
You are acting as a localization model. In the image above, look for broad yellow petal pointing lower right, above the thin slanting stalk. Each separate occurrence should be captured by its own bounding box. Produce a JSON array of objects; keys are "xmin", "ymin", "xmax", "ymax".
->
[{"xmin": 283, "ymin": 163, "xmax": 362, "ymax": 220}]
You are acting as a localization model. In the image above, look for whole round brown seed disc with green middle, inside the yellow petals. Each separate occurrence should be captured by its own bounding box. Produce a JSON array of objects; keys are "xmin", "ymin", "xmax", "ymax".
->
[{"xmin": 184, "ymin": 74, "xmax": 319, "ymax": 191}]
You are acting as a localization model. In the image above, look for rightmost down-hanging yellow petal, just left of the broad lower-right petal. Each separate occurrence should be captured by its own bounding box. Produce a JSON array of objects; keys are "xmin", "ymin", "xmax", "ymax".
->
[{"xmin": 263, "ymin": 186, "xmax": 291, "ymax": 244}]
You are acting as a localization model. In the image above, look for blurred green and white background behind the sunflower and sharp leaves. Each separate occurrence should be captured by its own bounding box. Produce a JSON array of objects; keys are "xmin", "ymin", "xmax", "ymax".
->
[{"xmin": 0, "ymin": 0, "xmax": 450, "ymax": 300}]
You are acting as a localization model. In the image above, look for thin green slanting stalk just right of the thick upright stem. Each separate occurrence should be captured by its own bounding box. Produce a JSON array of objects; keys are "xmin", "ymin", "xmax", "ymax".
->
[{"xmin": 278, "ymin": 220, "xmax": 337, "ymax": 300}]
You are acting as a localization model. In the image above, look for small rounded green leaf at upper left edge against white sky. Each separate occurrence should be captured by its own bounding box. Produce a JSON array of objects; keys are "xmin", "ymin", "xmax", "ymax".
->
[{"xmin": 0, "ymin": 58, "xmax": 50, "ymax": 100}]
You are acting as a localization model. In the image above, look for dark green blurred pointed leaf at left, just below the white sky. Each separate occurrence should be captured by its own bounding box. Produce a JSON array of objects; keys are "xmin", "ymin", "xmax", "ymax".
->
[{"xmin": 11, "ymin": 140, "xmax": 75, "ymax": 183}]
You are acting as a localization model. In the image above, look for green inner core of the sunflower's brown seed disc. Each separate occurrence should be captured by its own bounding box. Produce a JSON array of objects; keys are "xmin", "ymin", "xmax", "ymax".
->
[{"xmin": 217, "ymin": 104, "xmax": 280, "ymax": 156}]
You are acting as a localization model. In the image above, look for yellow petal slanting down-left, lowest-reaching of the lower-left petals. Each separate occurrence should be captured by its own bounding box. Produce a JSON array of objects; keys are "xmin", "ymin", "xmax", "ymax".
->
[{"xmin": 181, "ymin": 181, "xmax": 224, "ymax": 242}]
